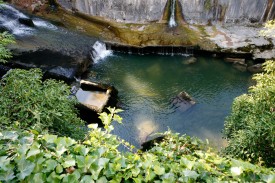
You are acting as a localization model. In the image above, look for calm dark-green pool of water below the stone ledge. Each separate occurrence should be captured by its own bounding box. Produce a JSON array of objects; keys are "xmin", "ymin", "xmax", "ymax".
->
[{"xmin": 89, "ymin": 54, "xmax": 252, "ymax": 147}]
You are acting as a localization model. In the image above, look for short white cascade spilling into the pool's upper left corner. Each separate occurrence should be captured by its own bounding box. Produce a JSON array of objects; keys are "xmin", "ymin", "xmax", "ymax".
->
[{"xmin": 91, "ymin": 41, "xmax": 113, "ymax": 63}]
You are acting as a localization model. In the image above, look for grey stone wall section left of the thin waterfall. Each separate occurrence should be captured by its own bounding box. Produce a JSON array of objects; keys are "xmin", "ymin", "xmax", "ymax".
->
[{"xmin": 64, "ymin": 0, "xmax": 167, "ymax": 23}]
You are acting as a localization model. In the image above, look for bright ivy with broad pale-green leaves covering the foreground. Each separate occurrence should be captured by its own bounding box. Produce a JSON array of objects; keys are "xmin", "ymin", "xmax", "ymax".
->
[{"xmin": 0, "ymin": 110, "xmax": 275, "ymax": 183}]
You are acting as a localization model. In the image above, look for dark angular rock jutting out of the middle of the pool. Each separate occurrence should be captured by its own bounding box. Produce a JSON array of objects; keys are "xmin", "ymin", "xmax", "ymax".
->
[{"xmin": 172, "ymin": 91, "xmax": 196, "ymax": 111}]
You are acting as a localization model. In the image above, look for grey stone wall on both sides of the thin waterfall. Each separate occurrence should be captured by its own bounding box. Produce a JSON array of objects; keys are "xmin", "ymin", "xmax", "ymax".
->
[{"xmin": 57, "ymin": 0, "xmax": 275, "ymax": 24}]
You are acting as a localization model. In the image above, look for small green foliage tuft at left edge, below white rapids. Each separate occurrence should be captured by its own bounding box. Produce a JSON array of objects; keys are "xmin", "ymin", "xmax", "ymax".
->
[{"xmin": 0, "ymin": 31, "xmax": 14, "ymax": 63}]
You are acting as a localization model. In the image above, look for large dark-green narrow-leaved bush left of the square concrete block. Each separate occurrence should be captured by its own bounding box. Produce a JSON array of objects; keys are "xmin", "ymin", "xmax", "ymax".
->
[{"xmin": 0, "ymin": 69, "xmax": 85, "ymax": 139}]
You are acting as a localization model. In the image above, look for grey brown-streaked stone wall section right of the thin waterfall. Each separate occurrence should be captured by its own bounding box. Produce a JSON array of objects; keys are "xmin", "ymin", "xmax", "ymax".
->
[{"xmin": 179, "ymin": 0, "xmax": 275, "ymax": 24}]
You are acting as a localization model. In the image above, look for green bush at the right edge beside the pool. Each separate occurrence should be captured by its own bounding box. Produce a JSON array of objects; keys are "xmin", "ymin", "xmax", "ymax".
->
[{"xmin": 224, "ymin": 61, "xmax": 275, "ymax": 166}]
